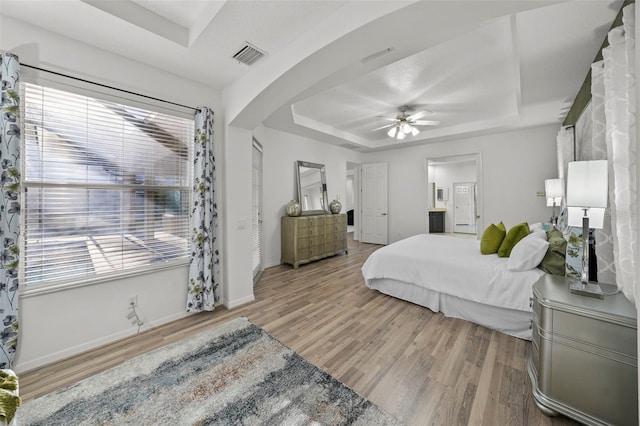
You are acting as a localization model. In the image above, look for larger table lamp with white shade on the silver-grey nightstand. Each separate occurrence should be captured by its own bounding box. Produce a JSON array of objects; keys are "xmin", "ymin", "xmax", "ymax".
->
[{"xmin": 567, "ymin": 160, "xmax": 609, "ymax": 299}]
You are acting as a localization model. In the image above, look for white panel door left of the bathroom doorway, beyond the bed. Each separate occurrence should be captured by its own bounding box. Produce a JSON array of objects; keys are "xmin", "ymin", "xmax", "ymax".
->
[{"xmin": 360, "ymin": 163, "xmax": 389, "ymax": 244}]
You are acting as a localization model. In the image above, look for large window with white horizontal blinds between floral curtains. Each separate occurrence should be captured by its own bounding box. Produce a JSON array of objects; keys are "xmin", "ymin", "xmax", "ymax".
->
[{"xmin": 22, "ymin": 84, "xmax": 194, "ymax": 286}]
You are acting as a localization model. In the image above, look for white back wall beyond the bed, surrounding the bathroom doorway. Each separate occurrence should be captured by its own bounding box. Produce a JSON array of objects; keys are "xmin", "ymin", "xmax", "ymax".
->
[{"xmin": 363, "ymin": 125, "xmax": 559, "ymax": 243}]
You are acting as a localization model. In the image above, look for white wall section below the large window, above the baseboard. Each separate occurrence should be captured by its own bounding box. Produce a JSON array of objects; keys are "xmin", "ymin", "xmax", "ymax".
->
[{"xmin": 14, "ymin": 265, "xmax": 189, "ymax": 372}]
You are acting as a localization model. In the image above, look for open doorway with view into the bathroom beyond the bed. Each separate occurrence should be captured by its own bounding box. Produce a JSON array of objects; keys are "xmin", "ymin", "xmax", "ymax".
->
[{"xmin": 426, "ymin": 153, "xmax": 484, "ymax": 236}]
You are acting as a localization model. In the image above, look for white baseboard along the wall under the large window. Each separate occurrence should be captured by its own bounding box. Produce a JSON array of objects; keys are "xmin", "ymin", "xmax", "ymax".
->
[{"xmin": 13, "ymin": 312, "xmax": 192, "ymax": 374}]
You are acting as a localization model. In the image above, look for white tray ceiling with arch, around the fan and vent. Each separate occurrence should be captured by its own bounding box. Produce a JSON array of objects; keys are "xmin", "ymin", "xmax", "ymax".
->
[{"xmin": 0, "ymin": 0, "xmax": 621, "ymax": 151}]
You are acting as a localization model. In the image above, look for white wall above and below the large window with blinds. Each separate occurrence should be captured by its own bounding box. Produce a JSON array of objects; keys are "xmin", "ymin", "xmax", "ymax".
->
[{"xmin": 0, "ymin": 16, "xmax": 222, "ymax": 372}]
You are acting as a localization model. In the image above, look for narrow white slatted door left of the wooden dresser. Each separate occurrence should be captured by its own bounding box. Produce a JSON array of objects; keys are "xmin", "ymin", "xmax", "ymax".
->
[{"xmin": 251, "ymin": 139, "xmax": 262, "ymax": 284}]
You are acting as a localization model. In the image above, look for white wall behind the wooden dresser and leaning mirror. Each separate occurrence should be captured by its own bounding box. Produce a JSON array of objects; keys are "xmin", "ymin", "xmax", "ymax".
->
[{"xmin": 255, "ymin": 126, "xmax": 361, "ymax": 267}]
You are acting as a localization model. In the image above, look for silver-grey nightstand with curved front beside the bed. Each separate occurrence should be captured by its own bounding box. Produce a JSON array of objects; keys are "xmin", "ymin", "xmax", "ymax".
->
[{"xmin": 528, "ymin": 274, "xmax": 638, "ymax": 425}]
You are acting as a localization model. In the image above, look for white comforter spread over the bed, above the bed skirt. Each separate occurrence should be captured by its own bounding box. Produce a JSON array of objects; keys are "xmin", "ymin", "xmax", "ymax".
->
[{"xmin": 362, "ymin": 234, "xmax": 544, "ymax": 311}]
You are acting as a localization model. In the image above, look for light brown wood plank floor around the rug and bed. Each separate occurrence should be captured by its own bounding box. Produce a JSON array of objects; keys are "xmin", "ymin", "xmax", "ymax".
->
[{"xmin": 20, "ymin": 236, "xmax": 577, "ymax": 426}]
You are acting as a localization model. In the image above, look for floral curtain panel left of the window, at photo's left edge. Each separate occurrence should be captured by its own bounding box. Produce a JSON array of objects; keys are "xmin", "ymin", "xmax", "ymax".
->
[{"xmin": 0, "ymin": 53, "xmax": 20, "ymax": 368}]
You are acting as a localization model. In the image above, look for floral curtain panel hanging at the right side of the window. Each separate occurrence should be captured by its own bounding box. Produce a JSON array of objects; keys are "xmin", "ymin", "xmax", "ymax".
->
[{"xmin": 187, "ymin": 108, "xmax": 220, "ymax": 312}]
